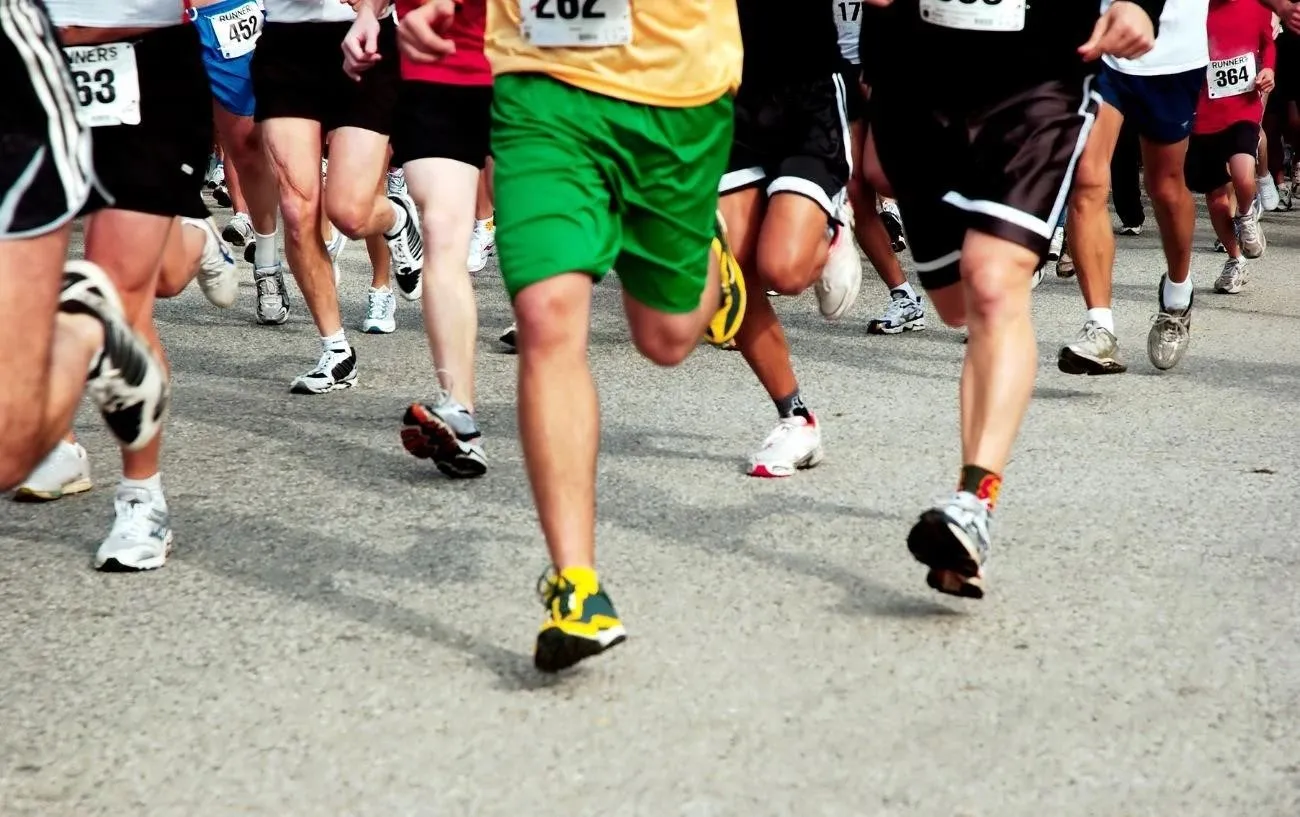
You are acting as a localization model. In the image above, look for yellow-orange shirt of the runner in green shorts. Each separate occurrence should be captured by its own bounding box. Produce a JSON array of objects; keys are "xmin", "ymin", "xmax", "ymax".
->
[{"xmin": 486, "ymin": 0, "xmax": 744, "ymax": 108}]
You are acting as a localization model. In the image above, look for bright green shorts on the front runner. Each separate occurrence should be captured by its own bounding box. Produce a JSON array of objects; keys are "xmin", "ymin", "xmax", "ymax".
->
[{"xmin": 491, "ymin": 74, "xmax": 732, "ymax": 314}]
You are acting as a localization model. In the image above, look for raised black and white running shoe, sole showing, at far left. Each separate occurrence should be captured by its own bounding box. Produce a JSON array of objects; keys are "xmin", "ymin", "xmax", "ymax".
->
[{"xmin": 59, "ymin": 260, "xmax": 172, "ymax": 451}]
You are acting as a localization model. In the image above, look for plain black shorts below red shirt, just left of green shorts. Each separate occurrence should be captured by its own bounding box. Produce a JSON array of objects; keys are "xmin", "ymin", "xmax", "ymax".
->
[{"xmin": 393, "ymin": 79, "xmax": 491, "ymax": 170}]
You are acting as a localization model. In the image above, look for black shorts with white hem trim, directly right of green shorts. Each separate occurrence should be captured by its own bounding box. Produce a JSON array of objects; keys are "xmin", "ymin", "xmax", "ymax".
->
[{"xmin": 718, "ymin": 74, "xmax": 853, "ymax": 219}]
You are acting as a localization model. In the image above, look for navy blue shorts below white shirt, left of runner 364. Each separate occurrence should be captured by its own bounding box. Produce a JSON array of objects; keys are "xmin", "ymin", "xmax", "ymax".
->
[{"xmin": 1097, "ymin": 65, "xmax": 1205, "ymax": 144}]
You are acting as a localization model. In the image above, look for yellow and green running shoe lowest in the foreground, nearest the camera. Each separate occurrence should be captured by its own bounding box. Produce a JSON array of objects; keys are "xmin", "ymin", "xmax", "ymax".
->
[{"xmin": 533, "ymin": 567, "xmax": 628, "ymax": 673}]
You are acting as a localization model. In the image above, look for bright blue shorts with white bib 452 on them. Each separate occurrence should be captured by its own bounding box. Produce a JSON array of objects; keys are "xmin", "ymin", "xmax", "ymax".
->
[{"xmin": 191, "ymin": 0, "xmax": 263, "ymax": 116}]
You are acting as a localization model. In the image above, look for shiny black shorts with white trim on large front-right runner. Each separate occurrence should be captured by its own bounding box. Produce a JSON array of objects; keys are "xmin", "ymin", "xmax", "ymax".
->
[{"xmin": 871, "ymin": 77, "xmax": 1101, "ymax": 289}]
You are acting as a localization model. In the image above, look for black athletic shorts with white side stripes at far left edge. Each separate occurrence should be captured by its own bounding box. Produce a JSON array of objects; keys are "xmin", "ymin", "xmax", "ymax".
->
[{"xmin": 0, "ymin": 0, "xmax": 107, "ymax": 239}]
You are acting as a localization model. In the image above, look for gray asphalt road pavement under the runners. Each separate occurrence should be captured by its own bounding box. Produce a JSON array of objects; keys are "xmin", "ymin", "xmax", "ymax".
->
[{"xmin": 0, "ymin": 199, "xmax": 1300, "ymax": 817}]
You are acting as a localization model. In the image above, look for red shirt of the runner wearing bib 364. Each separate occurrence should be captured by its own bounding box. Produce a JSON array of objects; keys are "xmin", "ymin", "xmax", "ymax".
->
[{"xmin": 1192, "ymin": 0, "xmax": 1278, "ymax": 134}]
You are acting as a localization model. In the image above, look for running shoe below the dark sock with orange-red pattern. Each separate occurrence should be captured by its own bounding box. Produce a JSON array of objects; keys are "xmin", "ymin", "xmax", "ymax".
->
[{"xmin": 907, "ymin": 490, "xmax": 989, "ymax": 598}]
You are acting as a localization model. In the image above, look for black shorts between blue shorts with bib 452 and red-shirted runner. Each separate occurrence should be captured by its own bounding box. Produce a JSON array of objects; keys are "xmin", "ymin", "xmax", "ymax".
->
[{"xmin": 252, "ymin": 17, "xmax": 400, "ymax": 135}]
